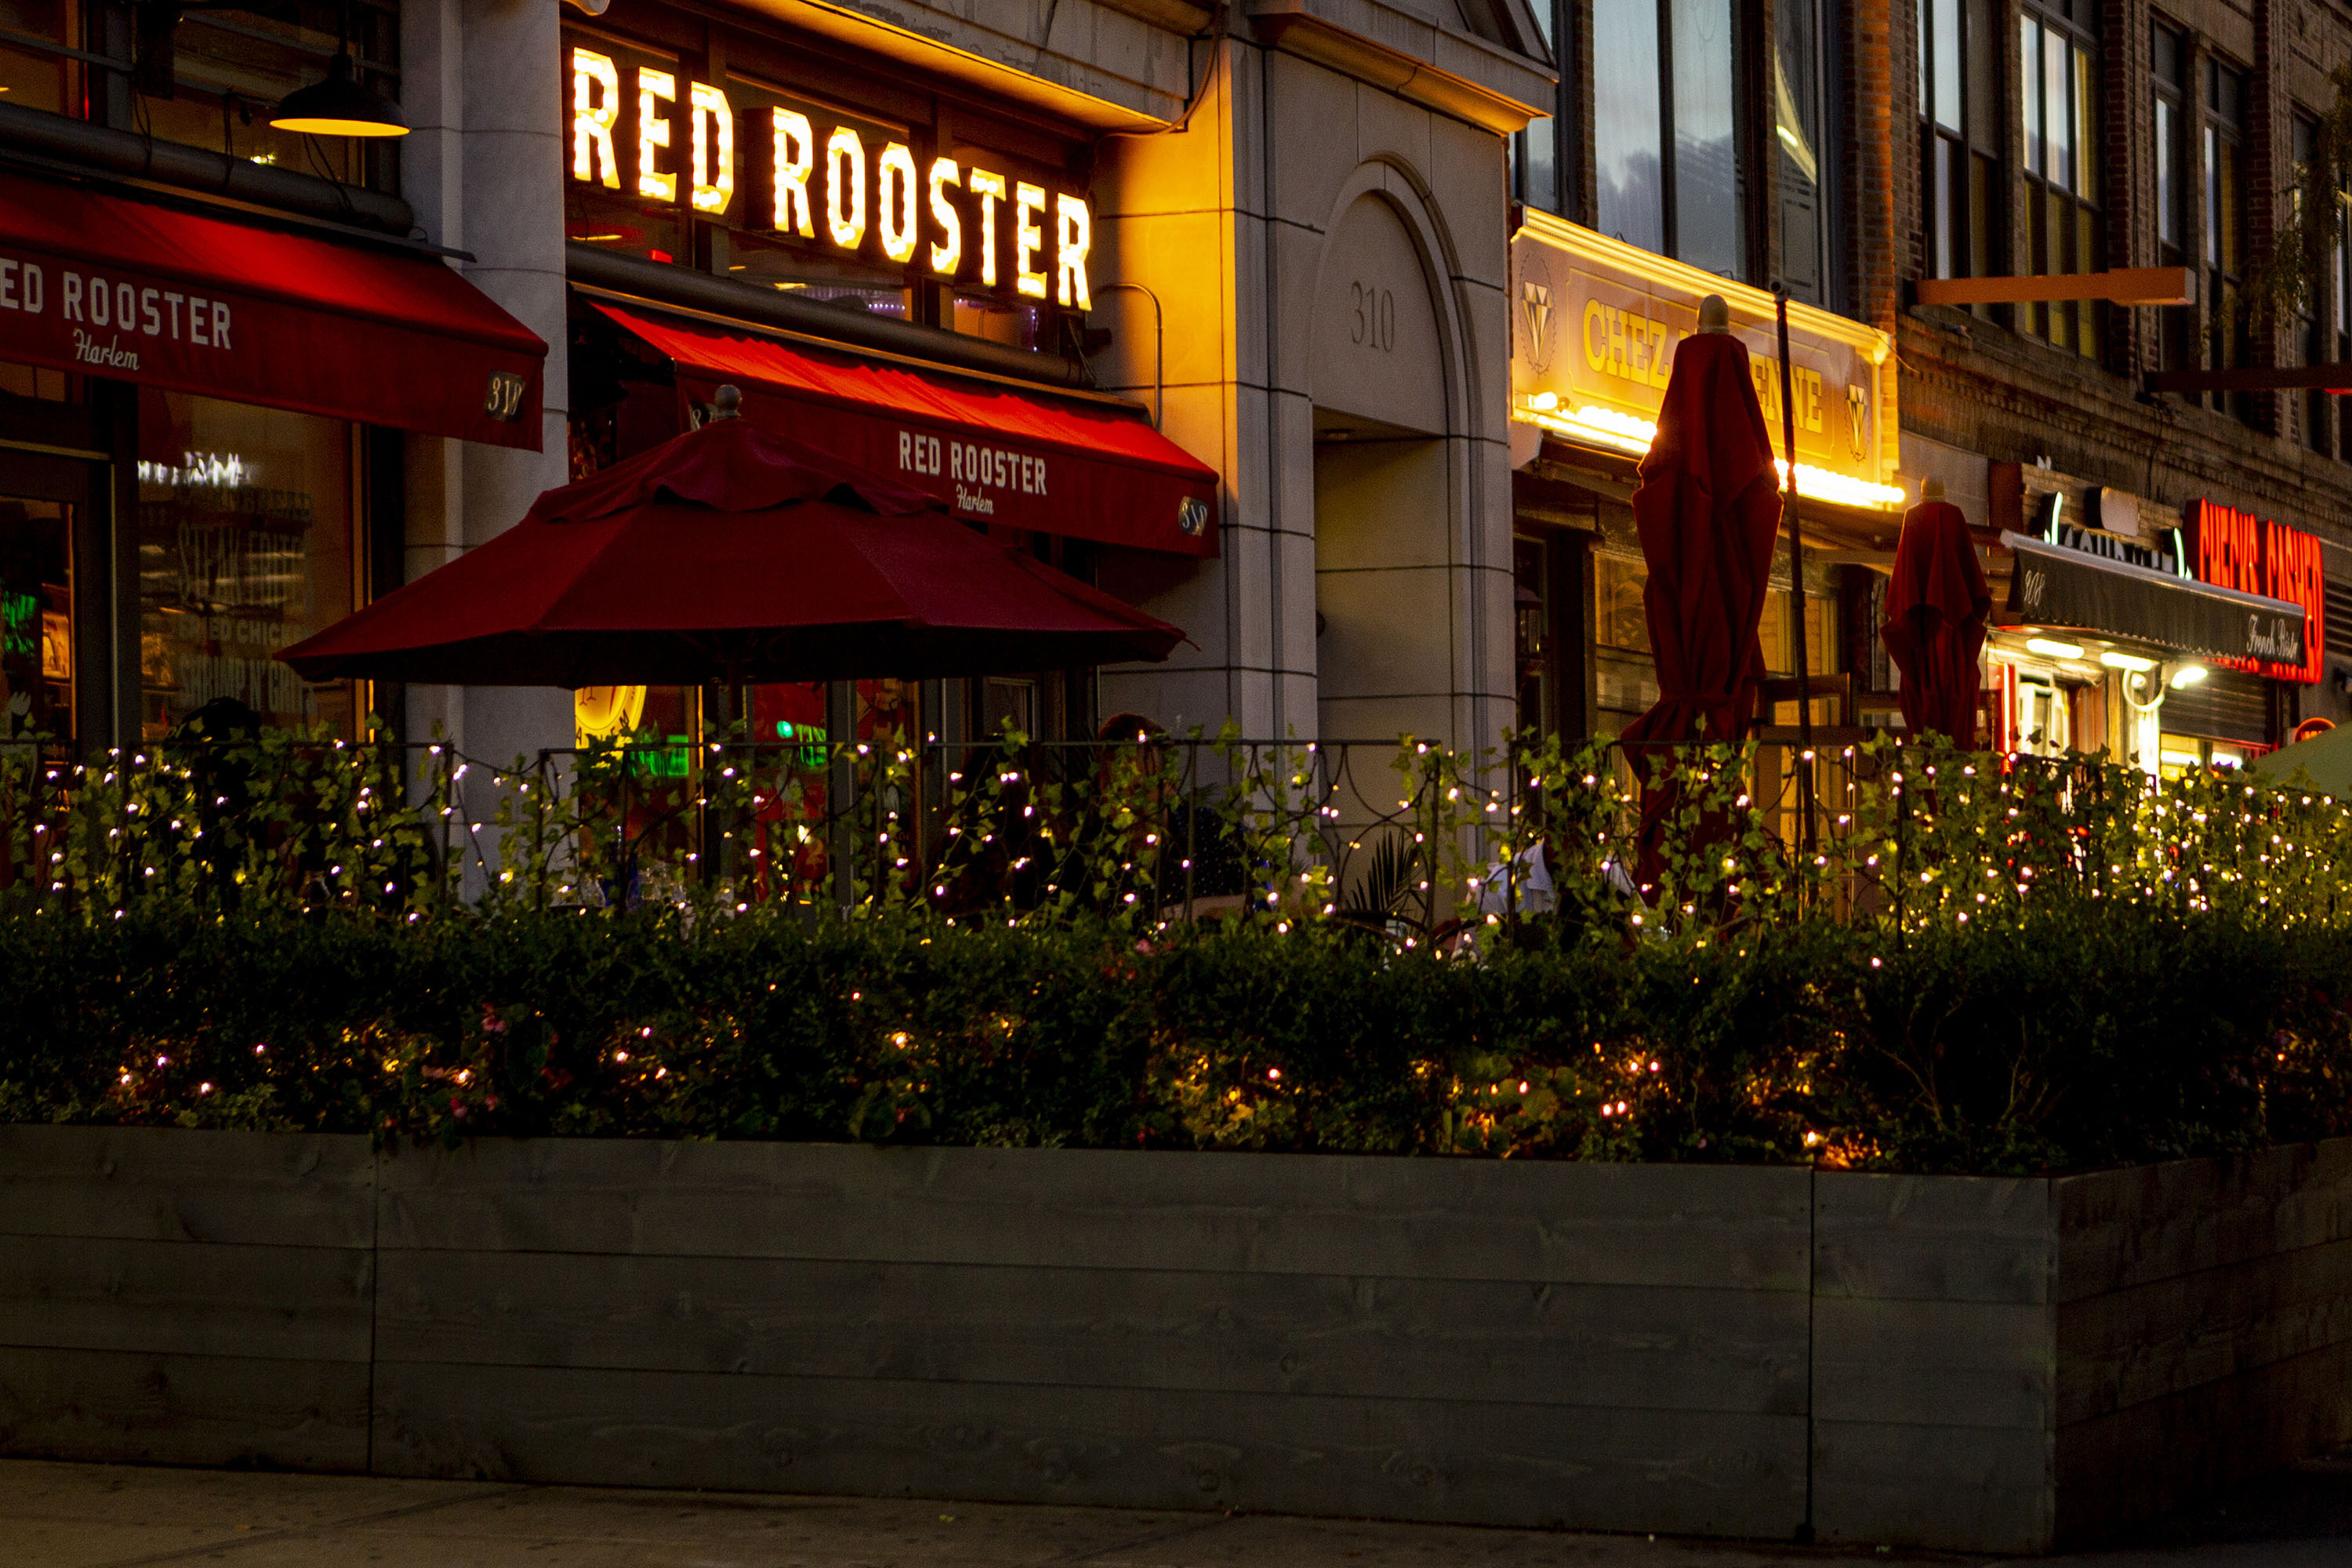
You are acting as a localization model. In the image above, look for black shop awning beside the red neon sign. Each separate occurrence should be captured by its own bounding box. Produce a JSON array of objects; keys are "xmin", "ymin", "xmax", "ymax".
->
[{"xmin": 2002, "ymin": 534, "xmax": 2303, "ymax": 666}]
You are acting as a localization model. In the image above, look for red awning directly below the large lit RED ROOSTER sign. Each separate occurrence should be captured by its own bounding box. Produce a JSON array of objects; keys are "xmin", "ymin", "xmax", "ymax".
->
[{"xmin": 597, "ymin": 303, "xmax": 1216, "ymax": 555}]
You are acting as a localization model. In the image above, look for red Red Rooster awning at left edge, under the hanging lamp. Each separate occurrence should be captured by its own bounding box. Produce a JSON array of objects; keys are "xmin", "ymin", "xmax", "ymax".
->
[{"xmin": 0, "ymin": 174, "xmax": 548, "ymax": 452}]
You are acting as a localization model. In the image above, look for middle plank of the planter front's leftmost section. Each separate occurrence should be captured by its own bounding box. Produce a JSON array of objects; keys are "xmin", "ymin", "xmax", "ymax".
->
[{"xmin": 0, "ymin": 1236, "xmax": 374, "ymax": 1361}]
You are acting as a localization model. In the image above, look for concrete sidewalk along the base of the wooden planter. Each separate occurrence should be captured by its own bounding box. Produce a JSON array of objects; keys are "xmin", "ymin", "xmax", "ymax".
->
[{"xmin": 0, "ymin": 1453, "xmax": 2352, "ymax": 1568}]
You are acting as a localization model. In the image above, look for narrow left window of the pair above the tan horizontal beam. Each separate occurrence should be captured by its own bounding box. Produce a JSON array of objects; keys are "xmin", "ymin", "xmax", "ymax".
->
[{"xmin": 1919, "ymin": 0, "xmax": 2002, "ymax": 278}]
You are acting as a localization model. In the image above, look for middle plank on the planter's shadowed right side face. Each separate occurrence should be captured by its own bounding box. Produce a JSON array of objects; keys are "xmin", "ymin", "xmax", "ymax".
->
[{"xmin": 2058, "ymin": 1241, "xmax": 2352, "ymax": 1425}]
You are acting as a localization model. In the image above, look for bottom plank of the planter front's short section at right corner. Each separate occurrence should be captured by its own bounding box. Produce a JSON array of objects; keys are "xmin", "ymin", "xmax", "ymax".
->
[{"xmin": 1813, "ymin": 1420, "xmax": 2056, "ymax": 1554}]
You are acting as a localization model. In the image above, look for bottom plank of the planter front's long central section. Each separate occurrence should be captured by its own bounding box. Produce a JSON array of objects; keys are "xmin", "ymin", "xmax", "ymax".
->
[{"xmin": 374, "ymin": 1363, "xmax": 1804, "ymax": 1537}]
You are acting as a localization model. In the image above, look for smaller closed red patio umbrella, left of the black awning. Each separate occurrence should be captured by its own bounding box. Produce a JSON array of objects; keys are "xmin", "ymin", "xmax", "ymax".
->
[{"xmin": 1879, "ymin": 489, "xmax": 1992, "ymax": 750}]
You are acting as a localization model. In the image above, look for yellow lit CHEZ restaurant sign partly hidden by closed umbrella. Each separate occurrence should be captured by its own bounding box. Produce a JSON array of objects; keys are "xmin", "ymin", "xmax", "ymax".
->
[{"xmin": 1510, "ymin": 209, "xmax": 1905, "ymax": 510}]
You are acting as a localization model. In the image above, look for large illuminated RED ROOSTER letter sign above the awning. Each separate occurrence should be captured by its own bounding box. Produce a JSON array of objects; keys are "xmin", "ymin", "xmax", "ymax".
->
[{"xmin": 567, "ymin": 38, "xmax": 1094, "ymax": 310}]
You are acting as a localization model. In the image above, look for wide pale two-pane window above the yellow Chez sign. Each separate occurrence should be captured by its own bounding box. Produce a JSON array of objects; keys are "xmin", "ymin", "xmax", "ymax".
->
[{"xmin": 1592, "ymin": 0, "xmax": 1748, "ymax": 278}]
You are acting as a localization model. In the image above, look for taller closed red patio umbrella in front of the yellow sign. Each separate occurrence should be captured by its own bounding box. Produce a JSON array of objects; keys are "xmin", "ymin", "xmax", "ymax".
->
[{"xmin": 1621, "ymin": 327, "xmax": 1780, "ymax": 881}]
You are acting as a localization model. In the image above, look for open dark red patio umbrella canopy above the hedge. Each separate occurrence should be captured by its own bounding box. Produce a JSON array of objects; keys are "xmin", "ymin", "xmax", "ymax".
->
[{"xmin": 280, "ymin": 419, "xmax": 1183, "ymax": 687}]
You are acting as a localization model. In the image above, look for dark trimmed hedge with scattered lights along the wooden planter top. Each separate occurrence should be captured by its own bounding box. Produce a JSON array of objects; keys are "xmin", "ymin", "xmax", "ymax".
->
[{"xmin": 0, "ymin": 900, "xmax": 2352, "ymax": 1173}]
